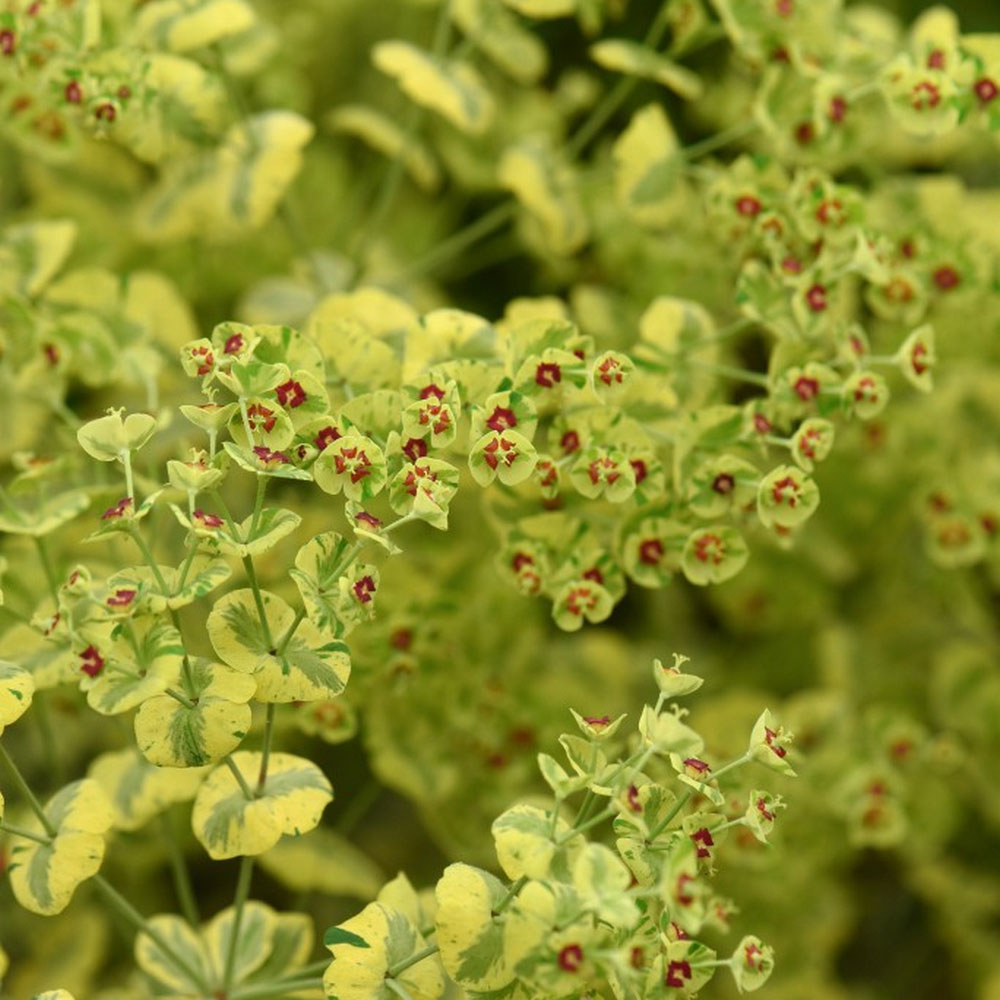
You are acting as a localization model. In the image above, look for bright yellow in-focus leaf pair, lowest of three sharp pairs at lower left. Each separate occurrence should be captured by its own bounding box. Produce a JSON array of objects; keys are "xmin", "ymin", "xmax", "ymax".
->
[{"xmin": 191, "ymin": 751, "xmax": 333, "ymax": 860}]
